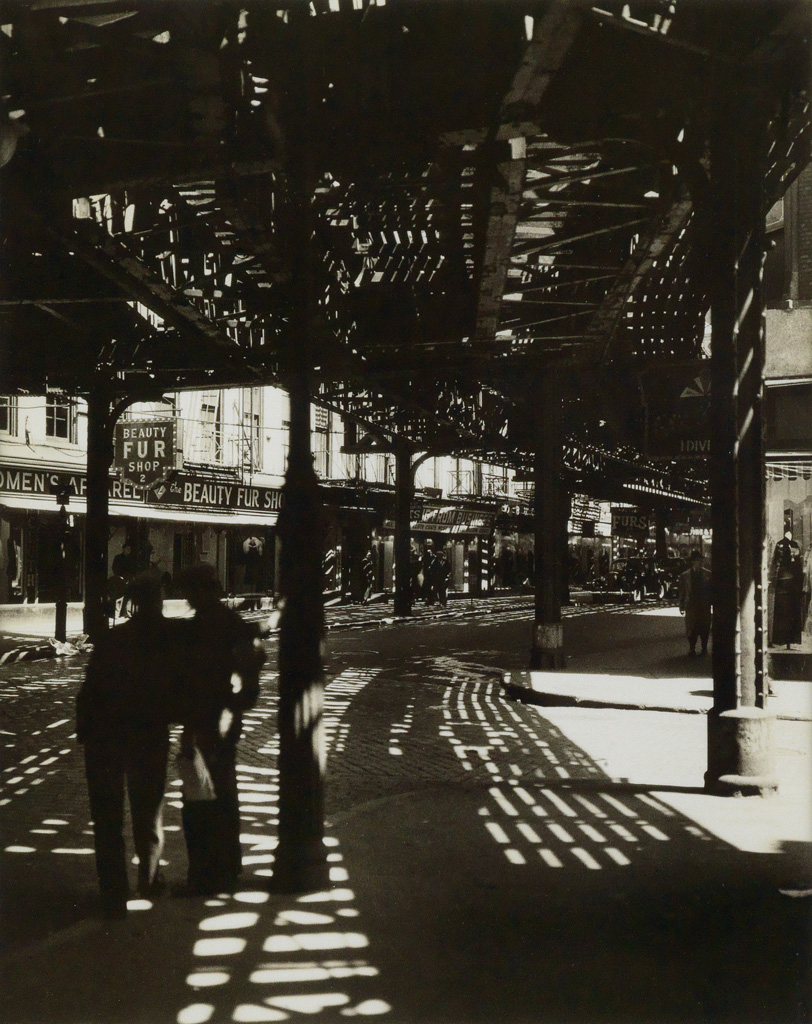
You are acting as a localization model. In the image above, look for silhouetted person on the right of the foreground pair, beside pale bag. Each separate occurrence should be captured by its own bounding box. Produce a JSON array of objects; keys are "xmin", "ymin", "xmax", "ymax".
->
[{"xmin": 175, "ymin": 565, "xmax": 265, "ymax": 895}]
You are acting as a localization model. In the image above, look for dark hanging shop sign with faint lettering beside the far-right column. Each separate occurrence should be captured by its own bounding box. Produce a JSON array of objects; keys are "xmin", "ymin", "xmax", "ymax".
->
[{"xmin": 643, "ymin": 359, "xmax": 711, "ymax": 459}]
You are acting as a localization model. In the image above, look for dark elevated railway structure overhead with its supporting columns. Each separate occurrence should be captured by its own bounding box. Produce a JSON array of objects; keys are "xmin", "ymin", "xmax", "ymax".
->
[{"xmin": 0, "ymin": 0, "xmax": 810, "ymax": 886}]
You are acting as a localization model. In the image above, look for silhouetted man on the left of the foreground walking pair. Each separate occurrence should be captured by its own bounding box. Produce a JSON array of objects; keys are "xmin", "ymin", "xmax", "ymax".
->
[{"xmin": 76, "ymin": 577, "xmax": 173, "ymax": 919}]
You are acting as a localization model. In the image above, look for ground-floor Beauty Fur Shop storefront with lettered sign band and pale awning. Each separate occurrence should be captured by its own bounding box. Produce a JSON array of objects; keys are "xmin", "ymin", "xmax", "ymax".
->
[{"xmin": 0, "ymin": 465, "xmax": 282, "ymax": 603}]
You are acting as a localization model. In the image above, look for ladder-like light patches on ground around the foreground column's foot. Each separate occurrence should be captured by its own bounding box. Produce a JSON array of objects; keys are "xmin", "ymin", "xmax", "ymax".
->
[{"xmin": 175, "ymin": 670, "xmax": 391, "ymax": 1024}]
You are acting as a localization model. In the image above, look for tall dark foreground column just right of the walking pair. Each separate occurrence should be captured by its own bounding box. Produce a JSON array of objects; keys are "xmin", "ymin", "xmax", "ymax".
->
[{"xmin": 270, "ymin": 9, "xmax": 330, "ymax": 892}]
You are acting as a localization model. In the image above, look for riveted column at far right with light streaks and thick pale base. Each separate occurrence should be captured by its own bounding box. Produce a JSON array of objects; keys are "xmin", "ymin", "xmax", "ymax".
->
[{"xmin": 706, "ymin": 88, "xmax": 777, "ymax": 793}]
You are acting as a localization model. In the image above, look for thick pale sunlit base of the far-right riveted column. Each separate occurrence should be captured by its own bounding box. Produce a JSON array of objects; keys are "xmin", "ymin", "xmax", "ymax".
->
[{"xmin": 704, "ymin": 708, "xmax": 778, "ymax": 796}]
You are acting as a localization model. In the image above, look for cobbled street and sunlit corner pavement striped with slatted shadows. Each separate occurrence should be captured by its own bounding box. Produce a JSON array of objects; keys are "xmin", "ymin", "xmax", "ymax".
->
[{"xmin": 0, "ymin": 604, "xmax": 812, "ymax": 1024}]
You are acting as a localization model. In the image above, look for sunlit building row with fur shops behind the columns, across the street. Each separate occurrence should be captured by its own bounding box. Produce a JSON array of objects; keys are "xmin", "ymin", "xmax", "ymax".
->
[{"xmin": 0, "ymin": 387, "xmax": 544, "ymax": 603}]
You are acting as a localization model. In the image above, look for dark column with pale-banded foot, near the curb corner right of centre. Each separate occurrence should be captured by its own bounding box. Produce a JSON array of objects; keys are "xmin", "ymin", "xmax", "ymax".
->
[{"xmin": 530, "ymin": 373, "xmax": 564, "ymax": 670}]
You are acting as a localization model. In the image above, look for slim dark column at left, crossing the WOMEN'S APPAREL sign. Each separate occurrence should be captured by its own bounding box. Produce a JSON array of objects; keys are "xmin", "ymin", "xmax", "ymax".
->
[{"xmin": 84, "ymin": 384, "xmax": 115, "ymax": 642}]
